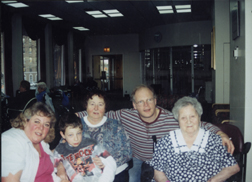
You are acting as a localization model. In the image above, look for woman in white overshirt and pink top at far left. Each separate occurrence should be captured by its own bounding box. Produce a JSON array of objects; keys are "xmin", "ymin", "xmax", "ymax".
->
[{"xmin": 1, "ymin": 102, "xmax": 68, "ymax": 182}]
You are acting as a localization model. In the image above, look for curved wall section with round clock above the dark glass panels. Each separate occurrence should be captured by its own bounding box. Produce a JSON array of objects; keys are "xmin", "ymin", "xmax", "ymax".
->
[{"xmin": 139, "ymin": 21, "xmax": 213, "ymax": 50}]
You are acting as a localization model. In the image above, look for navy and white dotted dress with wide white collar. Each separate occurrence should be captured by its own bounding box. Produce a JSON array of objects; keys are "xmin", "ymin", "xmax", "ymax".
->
[{"xmin": 150, "ymin": 129, "xmax": 236, "ymax": 182}]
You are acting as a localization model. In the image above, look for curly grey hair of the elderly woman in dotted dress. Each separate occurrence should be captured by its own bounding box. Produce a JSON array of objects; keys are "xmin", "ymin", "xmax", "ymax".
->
[{"xmin": 172, "ymin": 96, "xmax": 203, "ymax": 120}]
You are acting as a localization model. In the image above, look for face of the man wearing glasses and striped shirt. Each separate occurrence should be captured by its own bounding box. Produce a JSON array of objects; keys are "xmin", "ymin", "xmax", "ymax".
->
[{"xmin": 133, "ymin": 88, "xmax": 158, "ymax": 123}]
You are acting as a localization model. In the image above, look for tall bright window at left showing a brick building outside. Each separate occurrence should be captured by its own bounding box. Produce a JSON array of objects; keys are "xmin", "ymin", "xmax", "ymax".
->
[{"xmin": 23, "ymin": 35, "xmax": 38, "ymax": 89}]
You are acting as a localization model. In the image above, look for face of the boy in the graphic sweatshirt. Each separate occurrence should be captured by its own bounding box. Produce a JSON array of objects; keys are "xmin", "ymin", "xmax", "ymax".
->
[{"xmin": 60, "ymin": 126, "xmax": 82, "ymax": 147}]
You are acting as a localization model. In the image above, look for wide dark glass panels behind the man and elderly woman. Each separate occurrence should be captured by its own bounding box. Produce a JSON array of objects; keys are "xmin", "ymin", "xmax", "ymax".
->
[{"xmin": 141, "ymin": 45, "xmax": 212, "ymax": 95}]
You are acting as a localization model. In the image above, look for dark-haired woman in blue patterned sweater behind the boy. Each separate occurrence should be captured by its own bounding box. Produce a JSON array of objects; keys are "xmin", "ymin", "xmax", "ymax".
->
[{"xmin": 76, "ymin": 90, "xmax": 132, "ymax": 182}]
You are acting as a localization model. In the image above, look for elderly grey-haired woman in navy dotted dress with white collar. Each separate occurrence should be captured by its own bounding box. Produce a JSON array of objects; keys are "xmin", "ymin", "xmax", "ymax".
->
[{"xmin": 150, "ymin": 97, "xmax": 240, "ymax": 182}]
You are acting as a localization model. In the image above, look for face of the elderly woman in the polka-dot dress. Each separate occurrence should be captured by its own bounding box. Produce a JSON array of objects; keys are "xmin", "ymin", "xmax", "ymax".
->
[{"xmin": 178, "ymin": 105, "xmax": 200, "ymax": 134}]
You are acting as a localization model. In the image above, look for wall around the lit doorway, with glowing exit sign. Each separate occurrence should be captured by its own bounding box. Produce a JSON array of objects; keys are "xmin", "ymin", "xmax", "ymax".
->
[{"xmin": 85, "ymin": 34, "xmax": 141, "ymax": 94}]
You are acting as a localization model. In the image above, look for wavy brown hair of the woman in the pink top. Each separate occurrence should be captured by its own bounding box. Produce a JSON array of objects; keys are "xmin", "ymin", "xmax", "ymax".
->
[{"xmin": 11, "ymin": 102, "xmax": 56, "ymax": 143}]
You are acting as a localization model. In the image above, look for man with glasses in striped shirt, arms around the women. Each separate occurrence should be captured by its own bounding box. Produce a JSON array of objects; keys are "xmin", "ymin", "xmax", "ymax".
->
[{"xmin": 77, "ymin": 85, "xmax": 234, "ymax": 182}]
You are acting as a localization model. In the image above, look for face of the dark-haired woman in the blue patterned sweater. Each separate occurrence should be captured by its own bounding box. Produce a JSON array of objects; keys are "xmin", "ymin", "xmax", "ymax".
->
[{"xmin": 87, "ymin": 95, "xmax": 105, "ymax": 124}]
